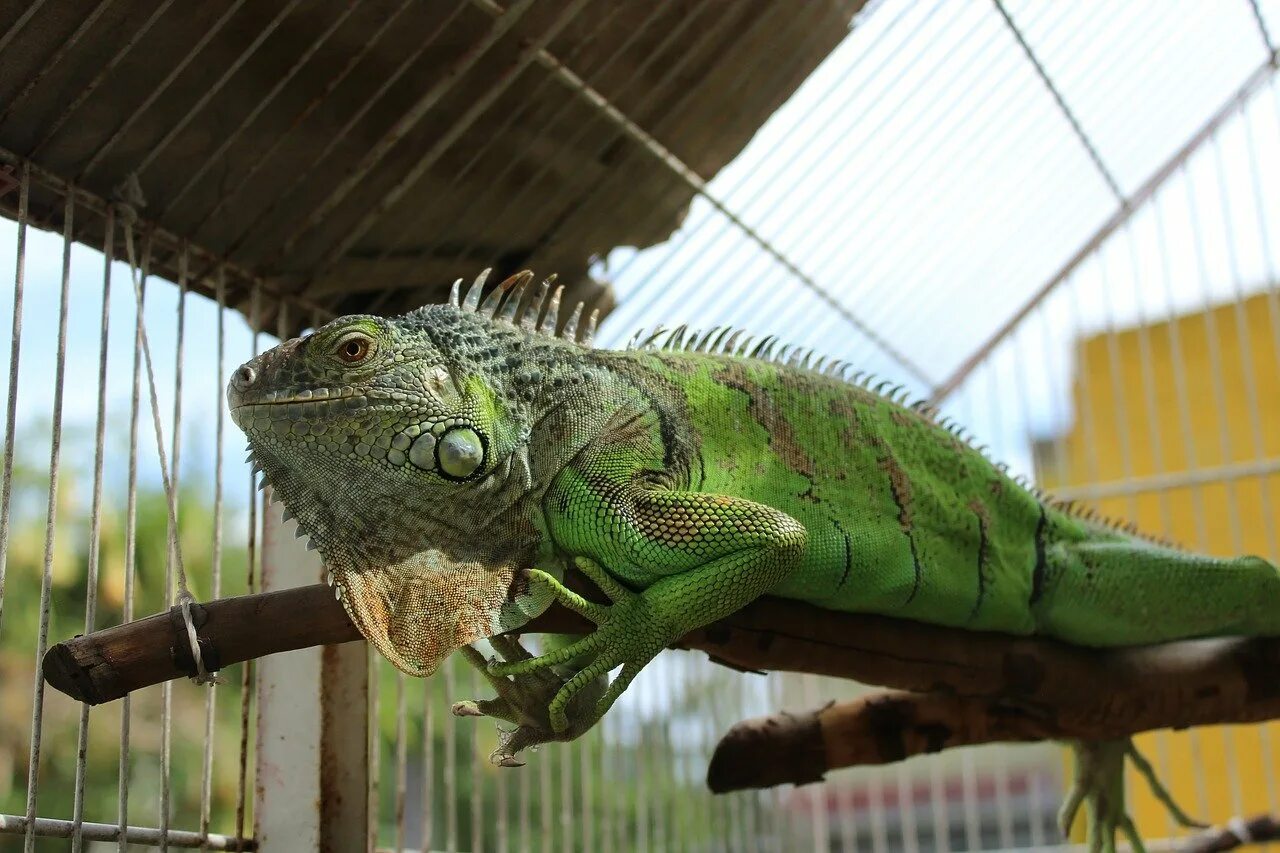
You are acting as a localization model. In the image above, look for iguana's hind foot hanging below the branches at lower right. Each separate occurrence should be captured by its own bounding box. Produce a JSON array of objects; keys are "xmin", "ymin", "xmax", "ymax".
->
[{"xmin": 1057, "ymin": 738, "xmax": 1206, "ymax": 853}]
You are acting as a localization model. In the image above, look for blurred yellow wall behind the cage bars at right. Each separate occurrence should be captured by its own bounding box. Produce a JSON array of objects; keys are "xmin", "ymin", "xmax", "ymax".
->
[{"xmin": 1037, "ymin": 289, "xmax": 1280, "ymax": 838}]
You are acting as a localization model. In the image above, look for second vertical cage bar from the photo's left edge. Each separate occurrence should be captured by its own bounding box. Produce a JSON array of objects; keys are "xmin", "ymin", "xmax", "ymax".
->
[{"xmin": 23, "ymin": 189, "xmax": 76, "ymax": 853}]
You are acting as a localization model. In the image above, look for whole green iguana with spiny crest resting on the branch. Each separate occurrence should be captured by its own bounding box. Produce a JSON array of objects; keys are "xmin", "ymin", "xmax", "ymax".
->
[{"xmin": 228, "ymin": 267, "xmax": 1280, "ymax": 849}]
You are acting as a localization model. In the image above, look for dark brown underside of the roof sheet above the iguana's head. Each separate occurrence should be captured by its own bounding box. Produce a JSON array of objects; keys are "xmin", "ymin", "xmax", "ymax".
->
[{"xmin": 0, "ymin": 0, "xmax": 861, "ymax": 333}]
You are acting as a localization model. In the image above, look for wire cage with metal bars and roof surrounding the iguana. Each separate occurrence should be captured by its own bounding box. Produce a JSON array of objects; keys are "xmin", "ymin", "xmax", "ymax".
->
[{"xmin": 0, "ymin": 0, "xmax": 1280, "ymax": 853}]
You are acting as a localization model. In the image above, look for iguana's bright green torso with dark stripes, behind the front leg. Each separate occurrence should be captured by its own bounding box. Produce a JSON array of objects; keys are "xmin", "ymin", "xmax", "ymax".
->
[{"xmin": 599, "ymin": 336, "xmax": 1280, "ymax": 646}]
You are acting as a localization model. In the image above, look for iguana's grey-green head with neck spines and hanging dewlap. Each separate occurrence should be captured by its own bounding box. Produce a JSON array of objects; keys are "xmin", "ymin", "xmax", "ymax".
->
[{"xmin": 227, "ymin": 268, "xmax": 601, "ymax": 675}]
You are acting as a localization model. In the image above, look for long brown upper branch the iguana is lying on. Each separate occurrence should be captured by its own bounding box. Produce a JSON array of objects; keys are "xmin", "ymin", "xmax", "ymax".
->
[{"xmin": 44, "ymin": 585, "xmax": 1280, "ymax": 753}]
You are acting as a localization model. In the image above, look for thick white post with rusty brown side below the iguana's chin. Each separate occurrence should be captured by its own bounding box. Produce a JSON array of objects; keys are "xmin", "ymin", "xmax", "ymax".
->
[{"xmin": 253, "ymin": 493, "xmax": 369, "ymax": 853}]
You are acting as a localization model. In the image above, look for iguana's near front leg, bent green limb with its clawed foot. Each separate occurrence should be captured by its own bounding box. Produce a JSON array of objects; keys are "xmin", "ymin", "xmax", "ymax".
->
[{"xmin": 489, "ymin": 478, "xmax": 805, "ymax": 753}]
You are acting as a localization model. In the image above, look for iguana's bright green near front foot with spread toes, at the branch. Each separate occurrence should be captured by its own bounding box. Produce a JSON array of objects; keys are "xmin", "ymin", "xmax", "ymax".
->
[{"xmin": 489, "ymin": 557, "xmax": 680, "ymax": 734}]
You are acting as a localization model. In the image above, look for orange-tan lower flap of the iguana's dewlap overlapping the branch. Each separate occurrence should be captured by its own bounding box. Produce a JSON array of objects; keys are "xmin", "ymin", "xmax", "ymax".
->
[{"xmin": 335, "ymin": 551, "xmax": 516, "ymax": 678}]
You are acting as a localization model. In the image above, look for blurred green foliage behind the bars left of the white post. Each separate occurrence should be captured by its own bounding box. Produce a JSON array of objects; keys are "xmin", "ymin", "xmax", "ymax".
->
[{"xmin": 0, "ymin": 428, "xmax": 247, "ymax": 849}]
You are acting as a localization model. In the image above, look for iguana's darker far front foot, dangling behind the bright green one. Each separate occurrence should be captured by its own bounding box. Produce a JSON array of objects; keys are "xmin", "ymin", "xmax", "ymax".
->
[{"xmin": 452, "ymin": 637, "xmax": 604, "ymax": 767}]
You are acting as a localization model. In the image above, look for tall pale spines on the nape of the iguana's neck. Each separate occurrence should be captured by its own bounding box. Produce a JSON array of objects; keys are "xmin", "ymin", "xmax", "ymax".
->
[{"xmin": 449, "ymin": 269, "xmax": 600, "ymax": 347}]
